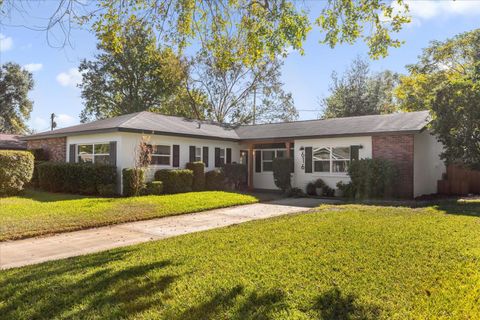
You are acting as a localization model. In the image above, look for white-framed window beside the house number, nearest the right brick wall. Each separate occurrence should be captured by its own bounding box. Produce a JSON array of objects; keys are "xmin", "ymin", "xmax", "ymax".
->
[{"xmin": 313, "ymin": 147, "xmax": 350, "ymax": 173}]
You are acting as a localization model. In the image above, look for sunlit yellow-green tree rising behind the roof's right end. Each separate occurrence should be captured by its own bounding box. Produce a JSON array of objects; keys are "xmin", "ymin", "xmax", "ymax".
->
[{"xmin": 395, "ymin": 29, "xmax": 480, "ymax": 111}]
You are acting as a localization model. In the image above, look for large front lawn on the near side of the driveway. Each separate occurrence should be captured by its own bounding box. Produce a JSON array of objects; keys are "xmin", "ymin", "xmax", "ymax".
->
[{"xmin": 0, "ymin": 202, "xmax": 480, "ymax": 319}]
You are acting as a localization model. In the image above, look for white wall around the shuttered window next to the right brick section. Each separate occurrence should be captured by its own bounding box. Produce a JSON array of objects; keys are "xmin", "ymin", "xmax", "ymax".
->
[{"xmin": 293, "ymin": 136, "xmax": 372, "ymax": 191}]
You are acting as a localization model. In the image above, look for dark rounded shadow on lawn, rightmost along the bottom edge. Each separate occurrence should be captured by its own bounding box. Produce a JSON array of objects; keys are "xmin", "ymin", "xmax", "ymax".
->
[{"xmin": 313, "ymin": 288, "xmax": 381, "ymax": 320}]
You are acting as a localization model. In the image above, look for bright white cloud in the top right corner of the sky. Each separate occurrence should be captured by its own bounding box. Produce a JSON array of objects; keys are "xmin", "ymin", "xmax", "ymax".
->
[{"xmin": 400, "ymin": 0, "xmax": 480, "ymax": 20}]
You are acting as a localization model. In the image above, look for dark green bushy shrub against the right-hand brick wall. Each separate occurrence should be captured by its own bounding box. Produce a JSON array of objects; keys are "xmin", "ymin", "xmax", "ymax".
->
[{"xmin": 348, "ymin": 159, "xmax": 398, "ymax": 199}]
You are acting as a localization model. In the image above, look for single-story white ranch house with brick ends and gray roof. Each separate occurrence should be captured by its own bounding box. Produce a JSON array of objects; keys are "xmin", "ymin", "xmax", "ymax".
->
[{"xmin": 23, "ymin": 111, "xmax": 445, "ymax": 198}]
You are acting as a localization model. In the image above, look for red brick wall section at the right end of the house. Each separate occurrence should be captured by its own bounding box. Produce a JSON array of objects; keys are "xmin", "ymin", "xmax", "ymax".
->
[{"xmin": 372, "ymin": 134, "xmax": 414, "ymax": 198}]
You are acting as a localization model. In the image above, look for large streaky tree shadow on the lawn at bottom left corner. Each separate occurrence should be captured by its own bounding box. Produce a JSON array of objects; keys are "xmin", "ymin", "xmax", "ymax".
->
[{"xmin": 0, "ymin": 250, "xmax": 179, "ymax": 319}]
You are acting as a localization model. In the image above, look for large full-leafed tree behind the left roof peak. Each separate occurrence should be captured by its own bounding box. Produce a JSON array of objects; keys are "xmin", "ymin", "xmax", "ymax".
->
[{"xmin": 79, "ymin": 18, "xmax": 204, "ymax": 122}]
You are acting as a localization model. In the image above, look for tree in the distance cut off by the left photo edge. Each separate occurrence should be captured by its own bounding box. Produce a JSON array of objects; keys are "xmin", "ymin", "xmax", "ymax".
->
[{"xmin": 0, "ymin": 62, "xmax": 33, "ymax": 134}]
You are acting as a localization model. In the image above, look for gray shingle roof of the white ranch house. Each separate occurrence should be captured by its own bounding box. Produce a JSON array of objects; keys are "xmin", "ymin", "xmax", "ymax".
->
[{"xmin": 24, "ymin": 111, "xmax": 429, "ymax": 140}]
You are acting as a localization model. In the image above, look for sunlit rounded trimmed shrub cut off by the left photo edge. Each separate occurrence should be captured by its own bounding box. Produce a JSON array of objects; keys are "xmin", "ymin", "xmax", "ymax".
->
[{"xmin": 0, "ymin": 150, "xmax": 34, "ymax": 195}]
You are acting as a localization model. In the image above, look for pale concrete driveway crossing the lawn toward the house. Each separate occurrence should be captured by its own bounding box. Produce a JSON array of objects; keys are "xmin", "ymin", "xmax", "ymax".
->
[{"xmin": 0, "ymin": 198, "xmax": 332, "ymax": 269}]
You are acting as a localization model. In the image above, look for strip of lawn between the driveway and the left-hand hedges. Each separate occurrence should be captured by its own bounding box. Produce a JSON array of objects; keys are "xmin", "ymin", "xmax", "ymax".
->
[{"xmin": 0, "ymin": 191, "xmax": 257, "ymax": 241}]
